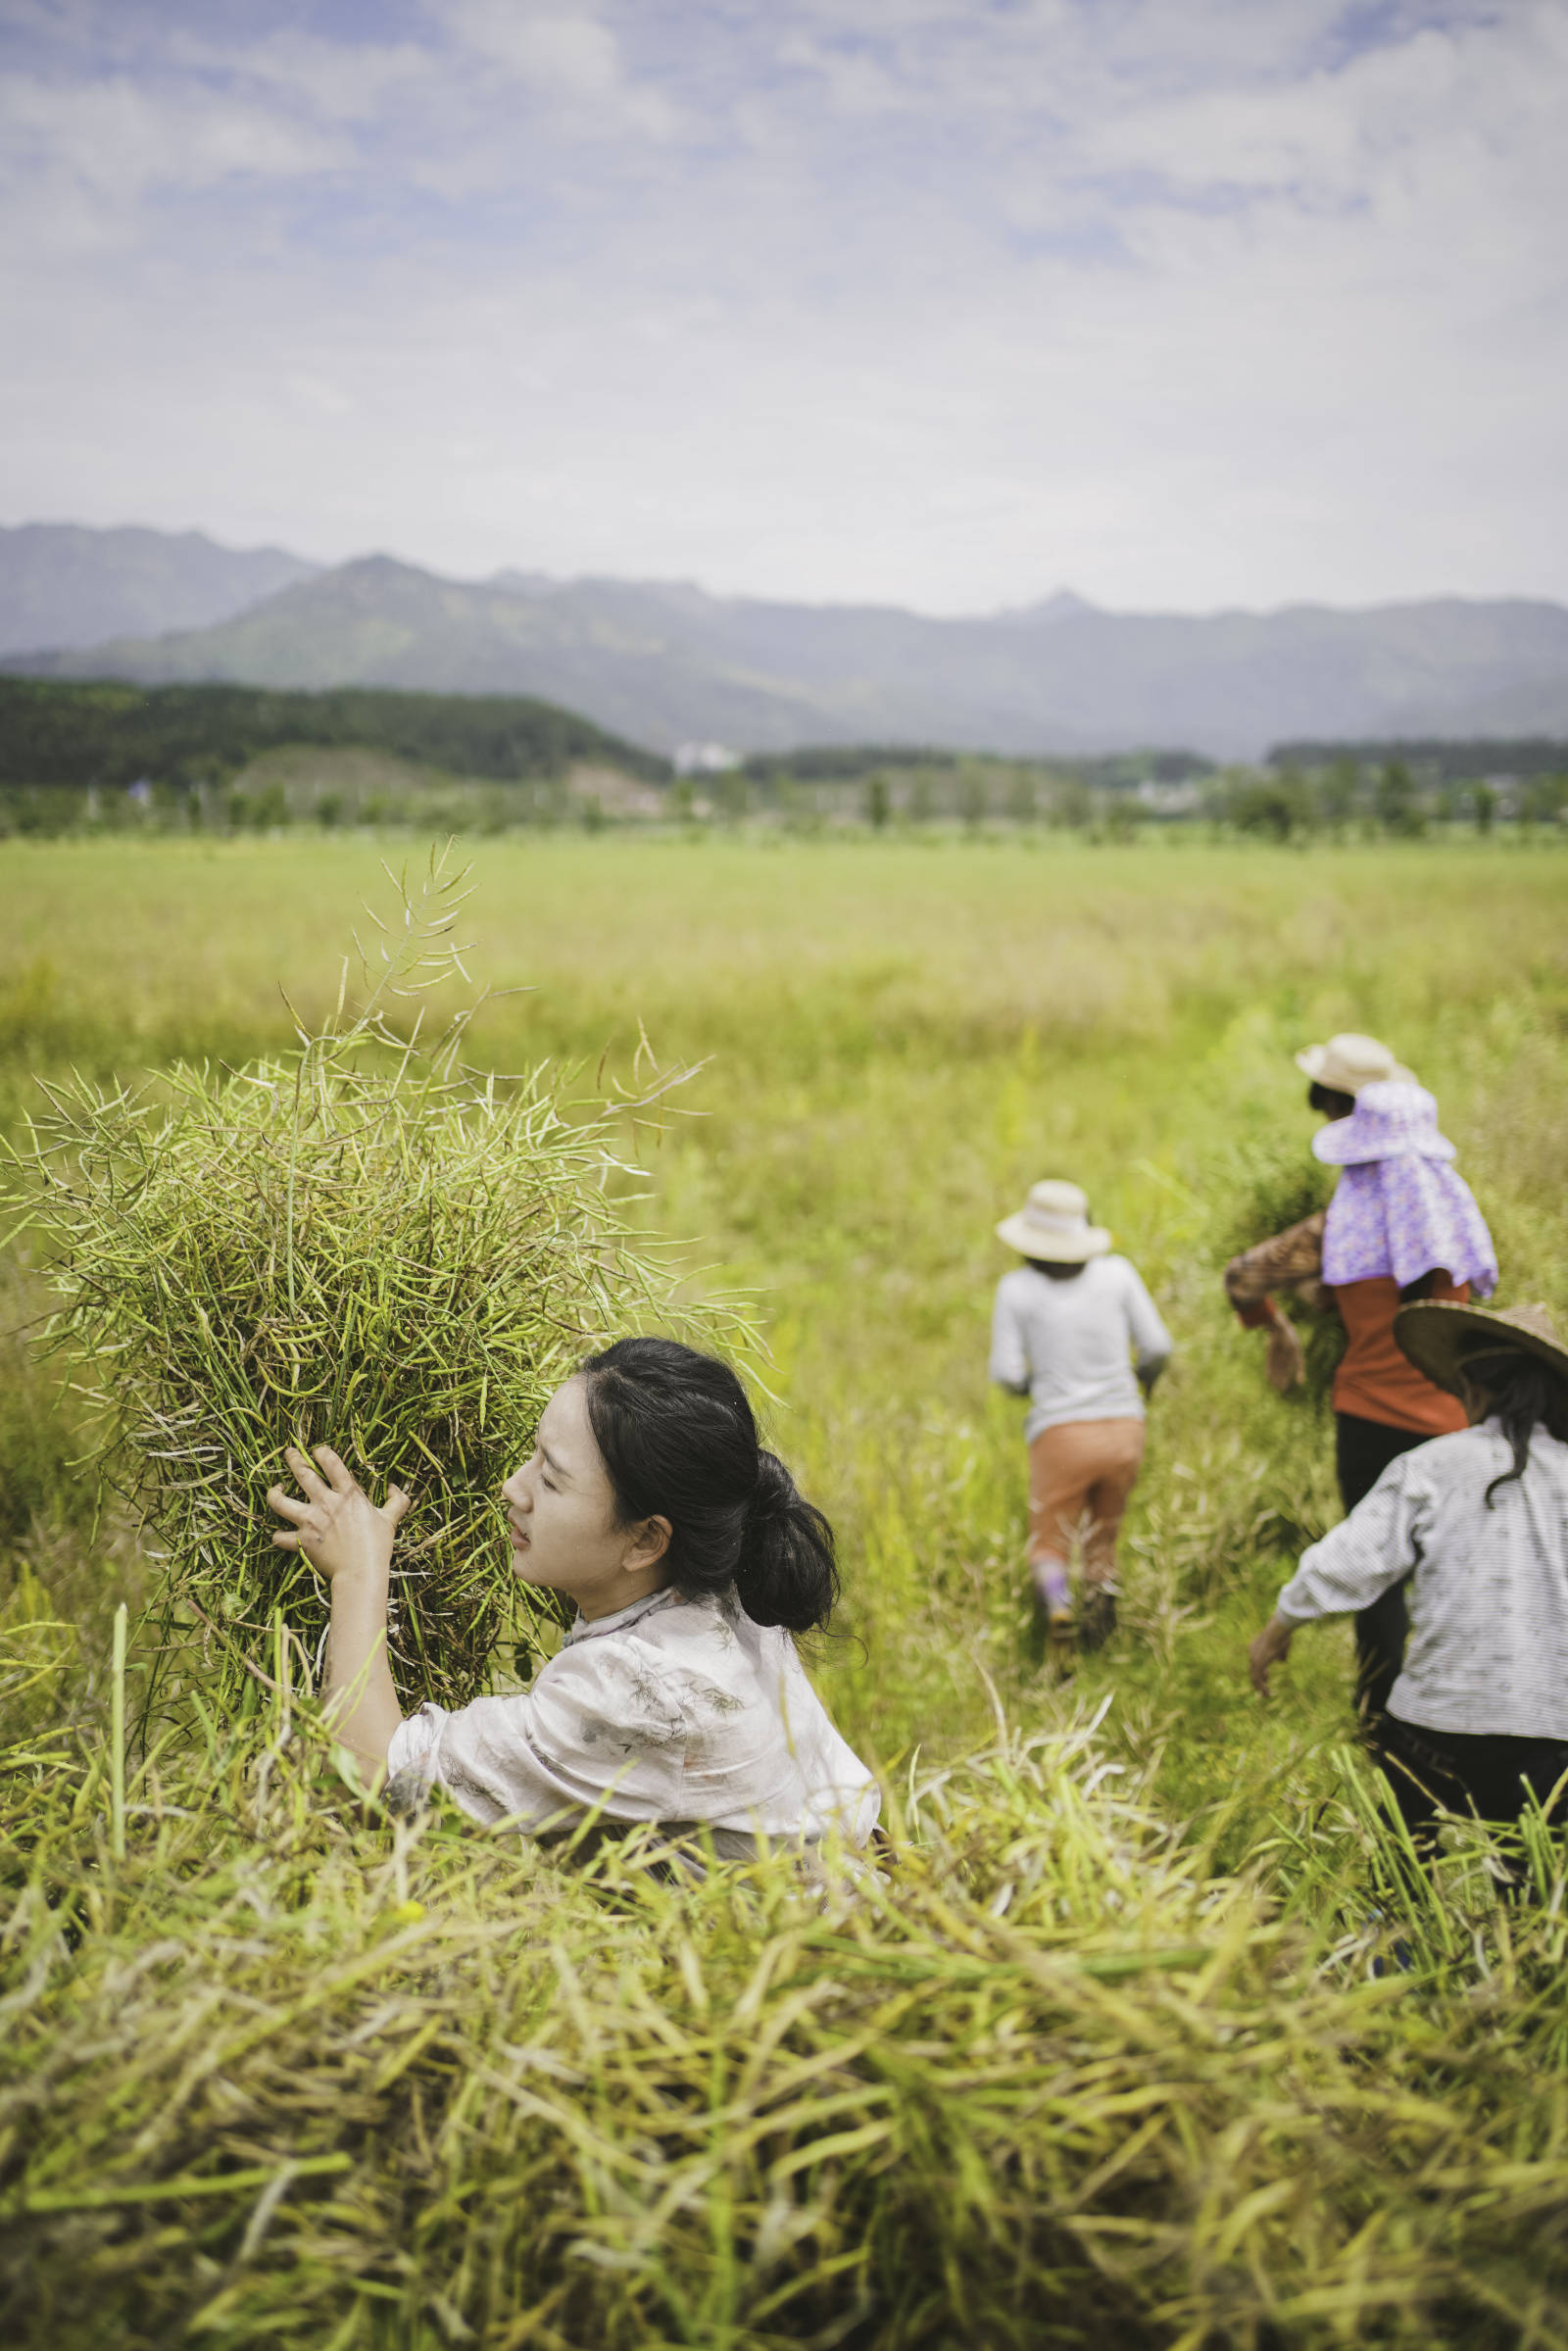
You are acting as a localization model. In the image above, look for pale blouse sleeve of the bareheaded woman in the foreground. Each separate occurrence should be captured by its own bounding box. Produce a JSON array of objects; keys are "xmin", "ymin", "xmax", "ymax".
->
[{"xmin": 388, "ymin": 1641, "xmax": 691, "ymax": 1829}]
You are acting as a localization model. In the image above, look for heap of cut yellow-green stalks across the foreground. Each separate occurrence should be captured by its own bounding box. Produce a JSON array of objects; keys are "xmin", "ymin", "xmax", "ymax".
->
[{"xmin": 0, "ymin": 1674, "xmax": 1568, "ymax": 2351}]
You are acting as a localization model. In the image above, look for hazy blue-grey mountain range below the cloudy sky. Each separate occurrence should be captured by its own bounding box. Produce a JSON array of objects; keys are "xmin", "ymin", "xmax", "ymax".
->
[{"xmin": 0, "ymin": 524, "xmax": 1568, "ymax": 757}]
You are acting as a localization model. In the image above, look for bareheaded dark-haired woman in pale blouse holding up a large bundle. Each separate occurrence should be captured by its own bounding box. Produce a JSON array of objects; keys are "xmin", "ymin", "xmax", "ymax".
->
[{"xmin": 268, "ymin": 1338, "xmax": 879, "ymax": 1860}]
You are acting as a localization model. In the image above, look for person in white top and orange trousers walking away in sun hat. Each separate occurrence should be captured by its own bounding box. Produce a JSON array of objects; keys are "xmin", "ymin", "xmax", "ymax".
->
[{"xmin": 990, "ymin": 1183, "xmax": 1171, "ymax": 1648}]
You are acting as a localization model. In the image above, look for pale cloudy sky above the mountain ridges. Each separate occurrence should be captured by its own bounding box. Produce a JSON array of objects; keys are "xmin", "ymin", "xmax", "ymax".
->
[{"xmin": 0, "ymin": 0, "xmax": 1568, "ymax": 613}]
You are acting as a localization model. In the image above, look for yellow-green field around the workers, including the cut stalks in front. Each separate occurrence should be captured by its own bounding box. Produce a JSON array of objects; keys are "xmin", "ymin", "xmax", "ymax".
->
[{"xmin": 0, "ymin": 835, "xmax": 1568, "ymax": 2351}]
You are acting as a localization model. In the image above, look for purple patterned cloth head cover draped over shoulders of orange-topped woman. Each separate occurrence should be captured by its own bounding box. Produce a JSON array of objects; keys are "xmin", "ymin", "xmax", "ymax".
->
[{"xmin": 1312, "ymin": 1079, "xmax": 1497, "ymax": 1298}]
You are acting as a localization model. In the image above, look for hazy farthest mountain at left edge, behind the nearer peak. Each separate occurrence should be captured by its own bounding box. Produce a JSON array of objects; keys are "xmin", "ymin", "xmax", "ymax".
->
[{"xmin": 0, "ymin": 522, "xmax": 319, "ymax": 654}]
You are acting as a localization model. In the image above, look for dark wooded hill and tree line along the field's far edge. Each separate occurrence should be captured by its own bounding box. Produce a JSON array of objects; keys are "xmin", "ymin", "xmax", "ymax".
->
[{"xmin": 0, "ymin": 677, "xmax": 1568, "ymax": 842}]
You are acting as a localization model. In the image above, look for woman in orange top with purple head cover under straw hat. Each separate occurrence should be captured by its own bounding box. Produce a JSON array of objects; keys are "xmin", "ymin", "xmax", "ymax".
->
[{"xmin": 1225, "ymin": 1035, "xmax": 1497, "ymax": 1744}]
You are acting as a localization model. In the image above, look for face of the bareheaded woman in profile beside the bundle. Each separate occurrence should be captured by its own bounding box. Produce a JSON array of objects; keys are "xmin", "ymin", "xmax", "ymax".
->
[{"xmin": 501, "ymin": 1380, "xmax": 670, "ymax": 1618}]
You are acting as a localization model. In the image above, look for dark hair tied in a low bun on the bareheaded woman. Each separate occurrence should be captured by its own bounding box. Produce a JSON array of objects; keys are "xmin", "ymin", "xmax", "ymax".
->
[{"xmin": 583, "ymin": 1338, "xmax": 839, "ymax": 1632}]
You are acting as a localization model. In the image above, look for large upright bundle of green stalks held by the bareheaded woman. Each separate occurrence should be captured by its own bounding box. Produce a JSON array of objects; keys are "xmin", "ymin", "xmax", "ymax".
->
[{"xmin": 1, "ymin": 858, "xmax": 686, "ymax": 1704}]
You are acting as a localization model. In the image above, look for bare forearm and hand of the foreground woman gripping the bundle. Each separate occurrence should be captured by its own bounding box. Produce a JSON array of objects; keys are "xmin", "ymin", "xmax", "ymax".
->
[{"xmin": 268, "ymin": 1445, "xmax": 409, "ymax": 1770}]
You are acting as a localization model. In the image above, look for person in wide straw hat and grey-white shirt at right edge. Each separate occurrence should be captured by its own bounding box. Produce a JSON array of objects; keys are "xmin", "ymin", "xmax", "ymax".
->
[{"xmin": 1249, "ymin": 1302, "xmax": 1568, "ymax": 1855}]
